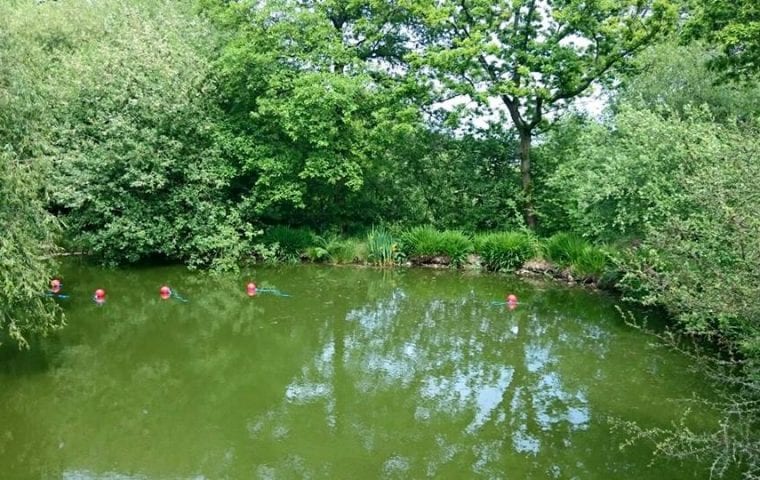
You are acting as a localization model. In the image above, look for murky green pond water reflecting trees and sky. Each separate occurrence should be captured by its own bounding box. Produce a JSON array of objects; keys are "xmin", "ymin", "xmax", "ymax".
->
[{"xmin": 0, "ymin": 262, "xmax": 720, "ymax": 480}]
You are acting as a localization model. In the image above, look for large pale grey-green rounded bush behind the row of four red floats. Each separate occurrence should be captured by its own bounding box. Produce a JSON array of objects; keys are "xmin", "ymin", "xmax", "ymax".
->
[{"xmin": 49, "ymin": 6, "xmax": 249, "ymax": 265}]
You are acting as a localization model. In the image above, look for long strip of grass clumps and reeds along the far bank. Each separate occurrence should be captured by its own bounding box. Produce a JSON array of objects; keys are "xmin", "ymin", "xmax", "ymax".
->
[{"xmin": 252, "ymin": 226, "xmax": 619, "ymax": 286}]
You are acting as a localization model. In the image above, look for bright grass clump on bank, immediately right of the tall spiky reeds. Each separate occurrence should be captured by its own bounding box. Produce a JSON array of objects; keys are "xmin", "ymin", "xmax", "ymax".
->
[{"xmin": 401, "ymin": 227, "xmax": 473, "ymax": 267}]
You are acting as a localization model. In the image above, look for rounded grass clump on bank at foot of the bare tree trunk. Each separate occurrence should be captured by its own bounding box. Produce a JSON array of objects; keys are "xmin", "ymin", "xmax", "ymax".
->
[{"xmin": 475, "ymin": 232, "xmax": 538, "ymax": 272}]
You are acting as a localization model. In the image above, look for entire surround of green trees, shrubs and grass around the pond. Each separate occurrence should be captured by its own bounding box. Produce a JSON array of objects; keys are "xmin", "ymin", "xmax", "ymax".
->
[{"xmin": 0, "ymin": 0, "xmax": 760, "ymax": 478}]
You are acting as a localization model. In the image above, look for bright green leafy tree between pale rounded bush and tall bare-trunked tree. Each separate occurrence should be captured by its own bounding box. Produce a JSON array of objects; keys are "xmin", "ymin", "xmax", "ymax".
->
[{"xmin": 202, "ymin": 2, "xmax": 422, "ymax": 228}]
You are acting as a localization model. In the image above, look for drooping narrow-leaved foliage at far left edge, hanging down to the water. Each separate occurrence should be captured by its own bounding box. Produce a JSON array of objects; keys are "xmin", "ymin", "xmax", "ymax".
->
[{"xmin": 0, "ymin": 2, "xmax": 62, "ymax": 347}]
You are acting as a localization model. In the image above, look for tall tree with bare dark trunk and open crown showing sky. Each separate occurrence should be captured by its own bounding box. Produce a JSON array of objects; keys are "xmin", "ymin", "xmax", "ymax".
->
[{"xmin": 412, "ymin": 0, "xmax": 677, "ymax": 227}]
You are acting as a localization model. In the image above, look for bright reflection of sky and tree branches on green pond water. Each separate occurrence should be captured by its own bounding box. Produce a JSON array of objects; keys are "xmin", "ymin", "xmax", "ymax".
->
[{"xmin": 252, "ymin": 276, "xmax": 624, "ymax": 478}]
